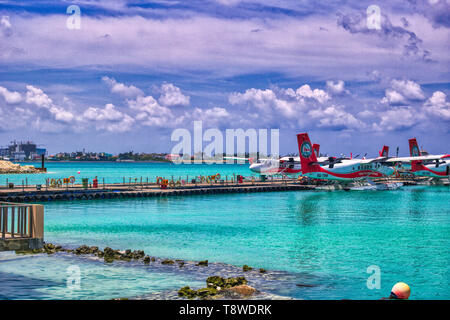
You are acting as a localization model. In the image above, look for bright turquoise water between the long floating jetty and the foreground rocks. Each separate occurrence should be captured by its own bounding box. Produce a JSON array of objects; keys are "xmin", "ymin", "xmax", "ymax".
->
[{"xmin": 0, "ymin": 172, "xmax": 450, "ymax": 299}]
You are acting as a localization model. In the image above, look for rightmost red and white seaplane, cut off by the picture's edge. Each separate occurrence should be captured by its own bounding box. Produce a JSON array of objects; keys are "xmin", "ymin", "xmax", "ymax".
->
[{"xmin": 387, "ymin": 138, "xmax": 450, "ymax": 179}]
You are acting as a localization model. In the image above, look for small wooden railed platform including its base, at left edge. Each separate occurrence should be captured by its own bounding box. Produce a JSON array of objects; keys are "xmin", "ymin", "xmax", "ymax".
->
[{"xmin": 0, "ymin": 202, "xmax": 44, "ymax": 251}]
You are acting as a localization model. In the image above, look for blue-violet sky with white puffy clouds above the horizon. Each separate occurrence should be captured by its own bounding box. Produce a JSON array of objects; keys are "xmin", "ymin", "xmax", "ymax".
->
[{"xmin": 0, "ymin": 0, "xmax": 450, "ymax": 155}]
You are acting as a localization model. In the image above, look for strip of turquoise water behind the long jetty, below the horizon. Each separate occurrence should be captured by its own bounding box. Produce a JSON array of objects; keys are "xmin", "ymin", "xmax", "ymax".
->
[{"xmin": 0, "ymin": 162, "xmax": 252, "ymax": 186}]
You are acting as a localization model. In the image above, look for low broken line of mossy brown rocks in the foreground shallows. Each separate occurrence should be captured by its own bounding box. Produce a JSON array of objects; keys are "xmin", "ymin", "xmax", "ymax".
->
[{"xmin": 16, "ymin": 243, "xmax": 290, "ymax": 300}]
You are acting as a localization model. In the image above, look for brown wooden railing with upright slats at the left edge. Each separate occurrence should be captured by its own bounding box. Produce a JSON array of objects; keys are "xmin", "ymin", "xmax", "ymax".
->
[{"xmin": 0, "ymin": 202, "xmax": 44, "ymax": 240}]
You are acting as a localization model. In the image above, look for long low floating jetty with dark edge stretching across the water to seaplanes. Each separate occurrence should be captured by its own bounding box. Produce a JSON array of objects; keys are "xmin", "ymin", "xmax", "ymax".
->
[{"xmin": 0, "ymin": 177, "xmax": 438, "ymax": 203}]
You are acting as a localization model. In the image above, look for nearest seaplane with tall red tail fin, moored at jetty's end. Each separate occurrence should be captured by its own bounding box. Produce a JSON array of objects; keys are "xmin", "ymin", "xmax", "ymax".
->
[{"xmin": 297, "ymin": 133, "xmax": 401, "ymax": 190}]
